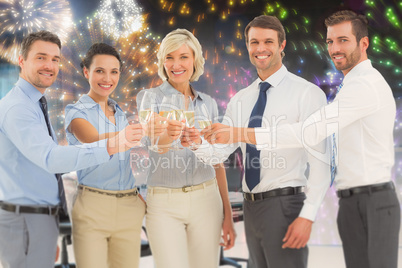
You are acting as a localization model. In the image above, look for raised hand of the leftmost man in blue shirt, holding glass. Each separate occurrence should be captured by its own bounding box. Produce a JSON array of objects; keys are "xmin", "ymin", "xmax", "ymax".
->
[{"xmin": 107, "ymin": 124, "xmax": 145, "ymax": 155}]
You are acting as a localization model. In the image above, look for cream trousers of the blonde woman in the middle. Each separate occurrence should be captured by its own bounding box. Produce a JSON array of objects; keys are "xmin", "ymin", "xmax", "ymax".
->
[{"xmin": 146, "ymin": 179, "xmax": 223, "ymax": 268}]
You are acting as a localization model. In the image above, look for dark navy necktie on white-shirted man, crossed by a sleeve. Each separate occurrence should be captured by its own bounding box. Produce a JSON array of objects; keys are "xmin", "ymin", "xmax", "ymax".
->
[{"xmin": 246, "ymin": 82, "xmax": 271, "ymax": 192}]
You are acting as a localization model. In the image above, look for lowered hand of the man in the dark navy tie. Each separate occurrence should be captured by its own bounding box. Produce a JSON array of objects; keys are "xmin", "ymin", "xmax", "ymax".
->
[{"xmin": 282, "ymin": 217, "xmax": 313, "ymax": 249}]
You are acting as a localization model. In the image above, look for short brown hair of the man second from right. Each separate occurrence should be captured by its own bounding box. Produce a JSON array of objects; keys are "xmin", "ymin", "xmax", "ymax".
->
[{"xmin": 244, "ymin": 15, "xmax": 286, "ymax": 44}]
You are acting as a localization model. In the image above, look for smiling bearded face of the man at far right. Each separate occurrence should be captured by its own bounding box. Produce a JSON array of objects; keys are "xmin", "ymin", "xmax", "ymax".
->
[{"xmin": 327, "ymin": 21, "xmax": 368, "ymax": 75}]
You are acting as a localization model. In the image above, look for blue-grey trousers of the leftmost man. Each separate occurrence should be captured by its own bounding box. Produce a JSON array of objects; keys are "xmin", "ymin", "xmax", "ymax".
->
[{"xmin": 0, "ymin": 209, "xmax": 59, "ymax": 268}]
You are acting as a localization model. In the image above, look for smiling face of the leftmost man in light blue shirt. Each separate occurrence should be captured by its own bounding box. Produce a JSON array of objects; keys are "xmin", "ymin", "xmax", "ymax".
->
[{"xmin": 18, "ymin": 40, "xmax": 60, "ymax": 94}]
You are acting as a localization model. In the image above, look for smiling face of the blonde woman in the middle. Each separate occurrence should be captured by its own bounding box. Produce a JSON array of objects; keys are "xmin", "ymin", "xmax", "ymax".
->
[{"xmin": 163, "ymin": 44, "xmax": 194, "ymax": 90}]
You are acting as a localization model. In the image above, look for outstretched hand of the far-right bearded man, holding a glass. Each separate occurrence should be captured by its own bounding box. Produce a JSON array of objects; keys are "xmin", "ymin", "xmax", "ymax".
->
[{"xmin": 201, "ymin": 123, "xmax": 236, "ymax": 144}]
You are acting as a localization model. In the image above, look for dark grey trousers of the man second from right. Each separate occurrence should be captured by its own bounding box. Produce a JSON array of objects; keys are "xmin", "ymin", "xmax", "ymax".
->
[{"xmin": 243, "ymin": 193, "xmax": 308, "ymax": 268}]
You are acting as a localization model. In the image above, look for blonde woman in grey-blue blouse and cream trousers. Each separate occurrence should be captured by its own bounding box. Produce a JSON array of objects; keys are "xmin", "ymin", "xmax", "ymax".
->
[{"xmin": 137, "ymin": 29, "xmax": 235, "ymax": 268}]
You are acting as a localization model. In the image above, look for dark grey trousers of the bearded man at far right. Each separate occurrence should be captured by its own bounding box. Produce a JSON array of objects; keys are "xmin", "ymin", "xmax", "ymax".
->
[{"xmin": 338, "ymin": 187, "xmax": 401, "ymax": 268}]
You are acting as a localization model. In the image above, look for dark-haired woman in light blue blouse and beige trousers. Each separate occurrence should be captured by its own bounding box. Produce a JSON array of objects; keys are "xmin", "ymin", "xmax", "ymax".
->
[{"xmin": 66, "ymin": 43, "xmax": 145, "ymax": 268}]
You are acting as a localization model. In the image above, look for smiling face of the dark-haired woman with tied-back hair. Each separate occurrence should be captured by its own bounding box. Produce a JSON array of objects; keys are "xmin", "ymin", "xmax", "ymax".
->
[{"xmin": 84, "ymin": 54, "xmax": 120, "ymax": 102}]
